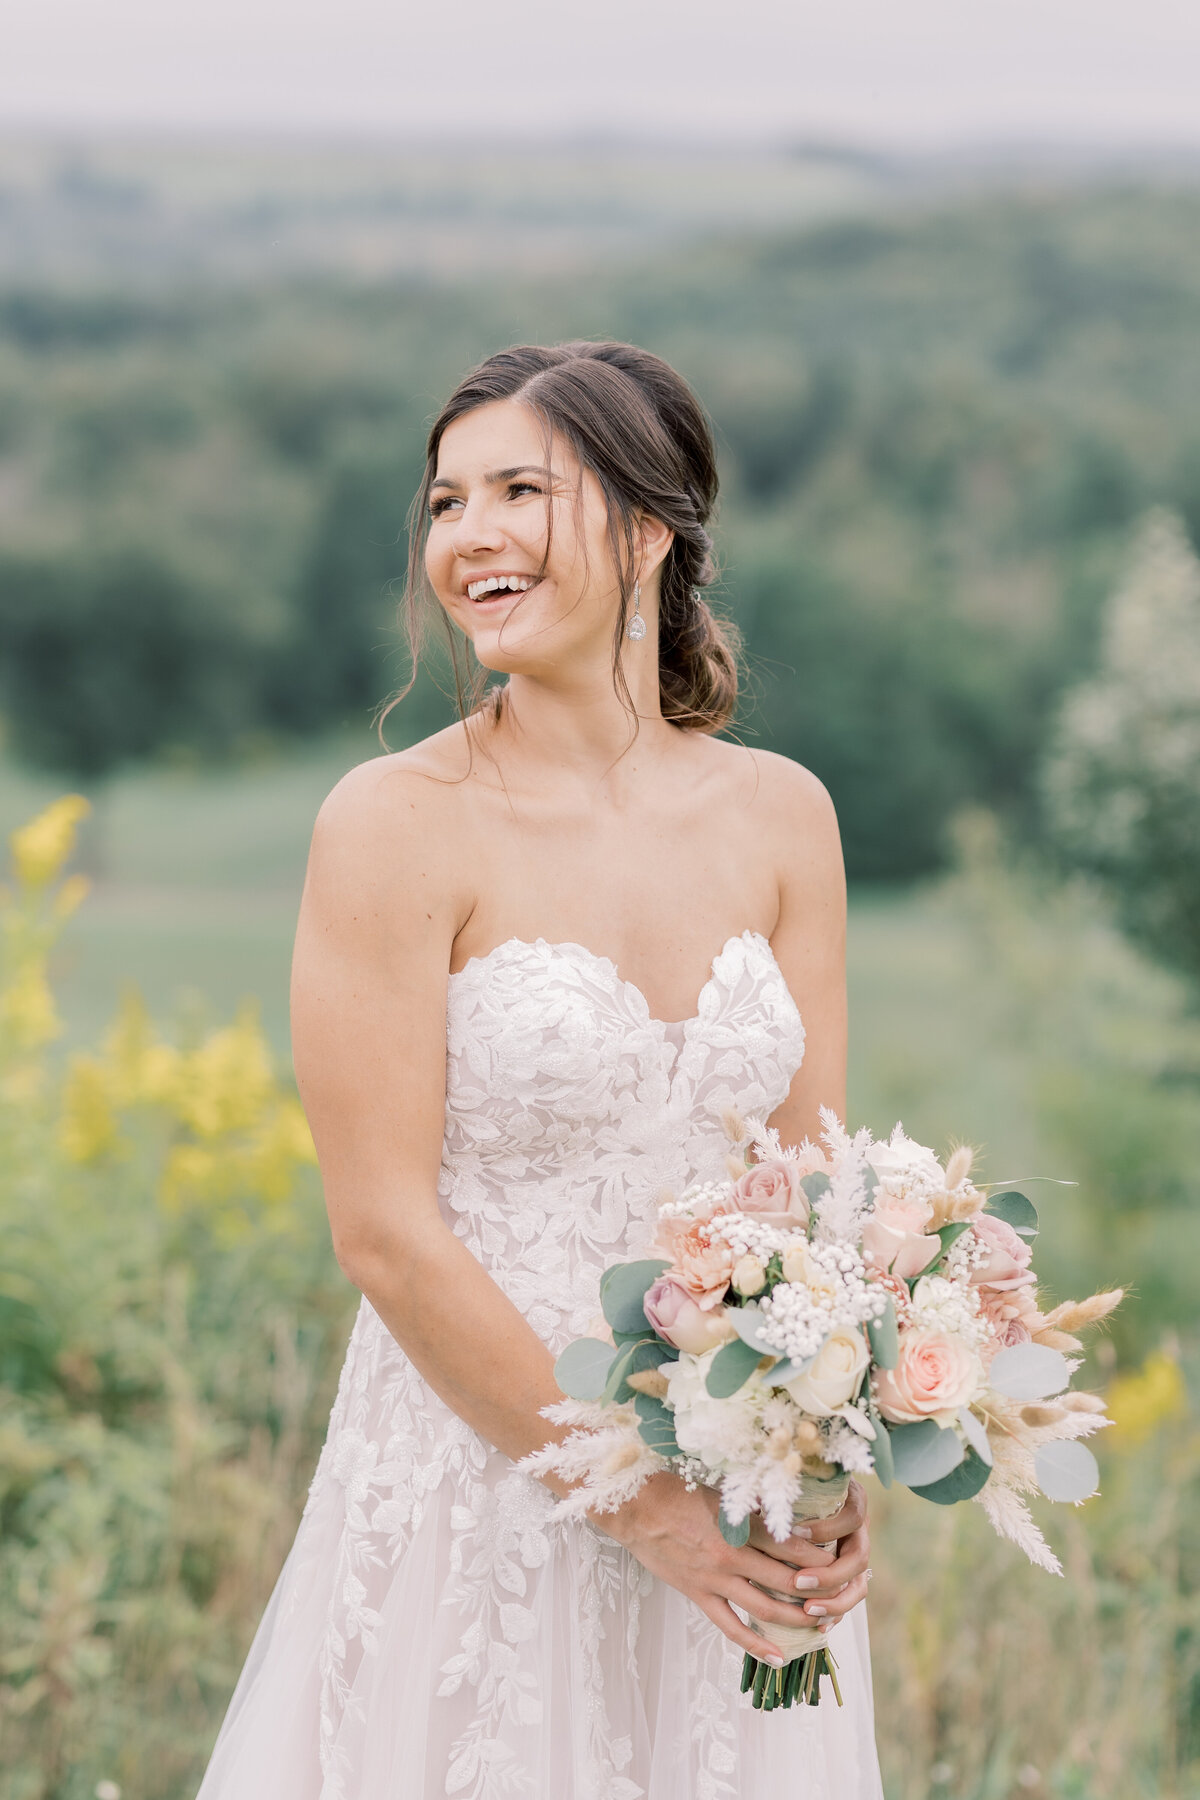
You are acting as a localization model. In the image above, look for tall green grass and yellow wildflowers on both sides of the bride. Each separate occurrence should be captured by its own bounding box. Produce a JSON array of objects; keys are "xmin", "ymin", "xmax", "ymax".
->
[{"xmin": 0, "ymin": 805, "xmax": 1200, "ymax": 1800}]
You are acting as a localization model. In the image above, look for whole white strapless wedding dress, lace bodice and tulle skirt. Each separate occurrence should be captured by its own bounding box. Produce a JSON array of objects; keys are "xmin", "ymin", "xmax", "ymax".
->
[{"xmin": 200, "ymin": 932, "xmax": 882, "ymax": 1800}]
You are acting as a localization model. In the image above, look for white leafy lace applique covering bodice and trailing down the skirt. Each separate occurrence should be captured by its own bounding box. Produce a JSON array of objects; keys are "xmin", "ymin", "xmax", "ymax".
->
[{"xmin": 305, "ymin": 932, "xmax": 804, "ymax": 1800}]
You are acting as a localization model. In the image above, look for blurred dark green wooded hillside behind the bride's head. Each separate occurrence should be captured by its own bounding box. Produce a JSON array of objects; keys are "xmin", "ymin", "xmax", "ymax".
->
[{"xmin": 0, "ymin": 189, "xmax": 1200, "ymax": 878}]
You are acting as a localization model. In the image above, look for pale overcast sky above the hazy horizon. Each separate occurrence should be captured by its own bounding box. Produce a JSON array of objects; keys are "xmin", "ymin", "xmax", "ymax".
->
[{"xmin": 0, "ymin": 0, "xmax": 1200, "ymax": 151}]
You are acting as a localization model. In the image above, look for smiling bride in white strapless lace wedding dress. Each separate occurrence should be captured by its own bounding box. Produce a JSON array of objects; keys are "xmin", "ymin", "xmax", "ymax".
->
[{"xmin": 200, "ymin": 344, "xmax": 882, "ymax": 1800}]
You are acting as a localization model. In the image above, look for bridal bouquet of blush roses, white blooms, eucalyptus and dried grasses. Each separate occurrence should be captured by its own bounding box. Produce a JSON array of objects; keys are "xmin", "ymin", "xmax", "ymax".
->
[{"xmin": 522, "ymin": 1109, "xmax": 1121, "ymax": 1710}]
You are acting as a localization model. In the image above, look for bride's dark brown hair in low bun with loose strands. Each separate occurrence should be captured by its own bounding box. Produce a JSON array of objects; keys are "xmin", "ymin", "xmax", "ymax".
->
[{"xmin": 389, "ymin": 342, "xmax": 738, "ymax": 731}]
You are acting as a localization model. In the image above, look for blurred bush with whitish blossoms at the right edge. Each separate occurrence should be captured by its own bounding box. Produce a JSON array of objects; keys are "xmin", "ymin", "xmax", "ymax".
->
[{"xmin": 1043, "ymin": 509, "xmax": 1200, "ymax": 979}]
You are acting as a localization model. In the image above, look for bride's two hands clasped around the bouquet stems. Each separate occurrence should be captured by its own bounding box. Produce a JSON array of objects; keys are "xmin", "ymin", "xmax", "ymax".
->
[{"xmin": 596, "ymin": 1471, "xmax": 867, "ymax": 1665}]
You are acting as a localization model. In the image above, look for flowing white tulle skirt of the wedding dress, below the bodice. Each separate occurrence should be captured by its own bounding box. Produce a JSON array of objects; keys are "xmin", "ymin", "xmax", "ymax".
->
[{"xmin": 200, "ymin": 1307, "xmax": 882, "ymax": 1800}]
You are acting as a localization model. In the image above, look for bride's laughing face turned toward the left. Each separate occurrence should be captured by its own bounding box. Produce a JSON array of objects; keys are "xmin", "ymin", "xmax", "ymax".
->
[{"xmin": 425, "ymin": 400, "xmax": 619, "ymax": 673}]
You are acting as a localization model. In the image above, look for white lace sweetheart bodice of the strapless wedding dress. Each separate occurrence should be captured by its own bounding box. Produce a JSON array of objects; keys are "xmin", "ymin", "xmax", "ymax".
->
[{"xmin": 439, "ymin": 931, "xmax": 804, "ymax": 1348}]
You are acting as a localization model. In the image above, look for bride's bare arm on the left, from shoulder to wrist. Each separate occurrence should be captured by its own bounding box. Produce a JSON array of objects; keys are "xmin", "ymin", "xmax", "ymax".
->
[{"xmin": 291, "ymin": 760, "xmax": 561, "ymax": 1460}]
